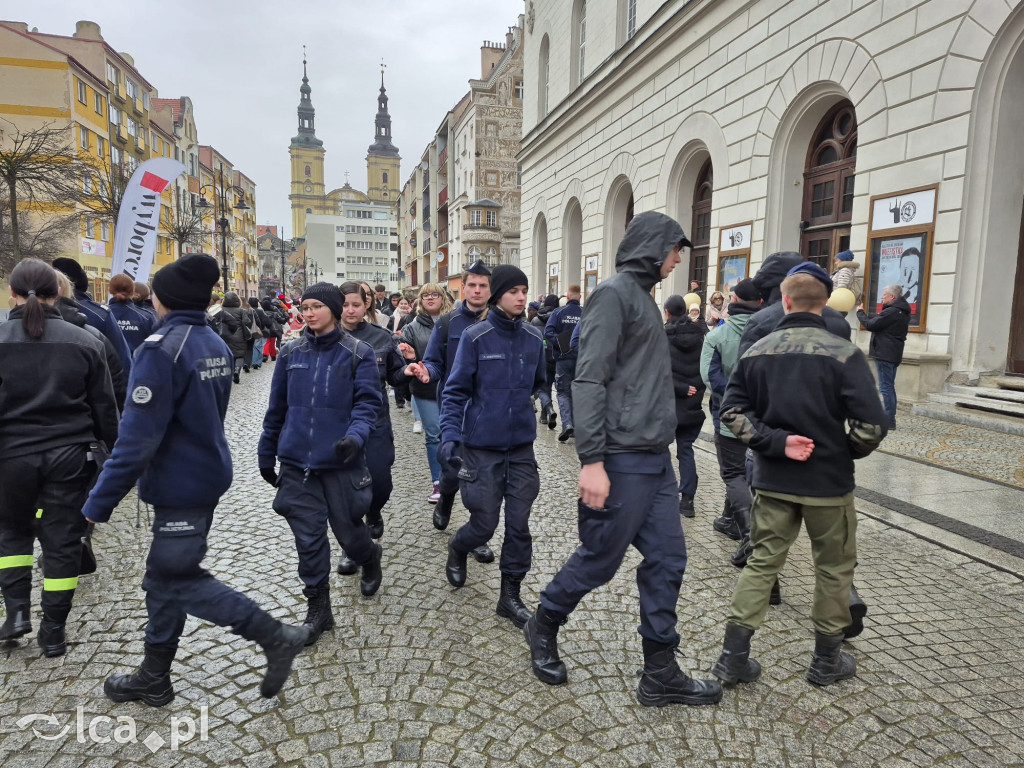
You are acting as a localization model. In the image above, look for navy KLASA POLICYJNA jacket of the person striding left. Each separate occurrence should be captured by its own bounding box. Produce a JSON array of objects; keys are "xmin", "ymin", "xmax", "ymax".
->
[{"xmin": 82, "ymin": 311, "xmax": 233, "ymax": 522}]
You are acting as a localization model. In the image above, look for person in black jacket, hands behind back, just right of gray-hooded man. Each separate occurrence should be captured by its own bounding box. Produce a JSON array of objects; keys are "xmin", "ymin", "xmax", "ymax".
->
[{"xmin": 665, "ymin": 296, "xmax": 708, "ymax": 517}]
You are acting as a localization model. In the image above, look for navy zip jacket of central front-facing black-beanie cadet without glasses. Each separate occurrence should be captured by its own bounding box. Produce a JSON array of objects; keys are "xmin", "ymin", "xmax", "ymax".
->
[{"xmin": 440, "ymin": 308, "xmax": 547, "ymax": 451}]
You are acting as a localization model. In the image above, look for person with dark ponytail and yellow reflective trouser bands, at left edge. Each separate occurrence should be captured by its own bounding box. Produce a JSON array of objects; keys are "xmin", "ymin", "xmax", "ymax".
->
[{"xmin": 0, "ymin": 259, "xmax": 118, "ymax": 656}]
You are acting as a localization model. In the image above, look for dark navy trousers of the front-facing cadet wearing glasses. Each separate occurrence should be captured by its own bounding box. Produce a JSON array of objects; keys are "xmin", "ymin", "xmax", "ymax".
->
[{"xmin": 273, "ymin": 464, "xmax": 374, "ymax": 587}]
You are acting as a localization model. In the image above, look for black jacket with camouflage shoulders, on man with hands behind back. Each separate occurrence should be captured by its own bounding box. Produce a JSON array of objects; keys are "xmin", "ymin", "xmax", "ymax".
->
[{"xmin": 722, "ymin": 312, "xmax": 886, "ymax": 497}]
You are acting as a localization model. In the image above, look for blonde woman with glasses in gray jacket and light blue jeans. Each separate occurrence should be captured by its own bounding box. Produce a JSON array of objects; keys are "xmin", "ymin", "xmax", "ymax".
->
[{"xmin": 398, "ymin": 283, "xmax": 452, "ymax": 504}]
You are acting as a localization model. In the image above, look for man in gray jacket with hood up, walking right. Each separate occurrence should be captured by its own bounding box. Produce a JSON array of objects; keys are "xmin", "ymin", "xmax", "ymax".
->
[{"xmin": 523, "ymin": 212, "xmax": 722, "ymax": 707}]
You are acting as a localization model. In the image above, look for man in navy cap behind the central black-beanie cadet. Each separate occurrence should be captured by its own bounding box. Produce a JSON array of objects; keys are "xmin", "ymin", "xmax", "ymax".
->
[{"xmin": 422, "ymin": 259, "xmax": 495, "ymax": 563}]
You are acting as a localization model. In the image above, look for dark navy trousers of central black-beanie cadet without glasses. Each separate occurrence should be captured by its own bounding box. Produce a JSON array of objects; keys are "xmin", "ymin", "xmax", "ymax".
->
[{"xmin": 452, "ymin": 443, "xmax": 541, "ymax": 575}]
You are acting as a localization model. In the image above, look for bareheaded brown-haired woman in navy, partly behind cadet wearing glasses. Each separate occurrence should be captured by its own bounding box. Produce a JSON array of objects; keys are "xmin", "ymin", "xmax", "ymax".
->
[{"xmin": 338, "ymin": 281, "xmax": 409, "ymax": 575}]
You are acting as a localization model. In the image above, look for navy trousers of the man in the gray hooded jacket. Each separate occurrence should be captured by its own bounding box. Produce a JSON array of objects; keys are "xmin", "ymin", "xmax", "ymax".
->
[{"xmin": 541, "ymin": 452, "xmax": 686, "ymax": 645}]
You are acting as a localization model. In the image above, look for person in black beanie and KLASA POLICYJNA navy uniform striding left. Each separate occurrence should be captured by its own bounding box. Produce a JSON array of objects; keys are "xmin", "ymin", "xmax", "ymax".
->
[{"xmin": 82, "ymin": 254, "xmax": 309, "ymax": 707}]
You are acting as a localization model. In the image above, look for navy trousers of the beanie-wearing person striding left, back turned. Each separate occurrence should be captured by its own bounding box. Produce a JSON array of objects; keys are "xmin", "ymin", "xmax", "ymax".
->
[{"xmin": 142, "ymin": 505, "xmax": 263, "ymax": 648}]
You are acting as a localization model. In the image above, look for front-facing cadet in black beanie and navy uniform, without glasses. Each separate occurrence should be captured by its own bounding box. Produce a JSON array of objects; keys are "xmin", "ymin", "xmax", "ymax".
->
[{"xmin": 421, "ymin": 264, "xmax": 545, "ymax": 627}]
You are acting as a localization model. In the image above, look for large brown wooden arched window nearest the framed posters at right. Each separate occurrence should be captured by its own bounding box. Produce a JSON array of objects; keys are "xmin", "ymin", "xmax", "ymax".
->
[{"xmin": 800, "ymin": 100, "xmax": 857, "ymax": 272}]
